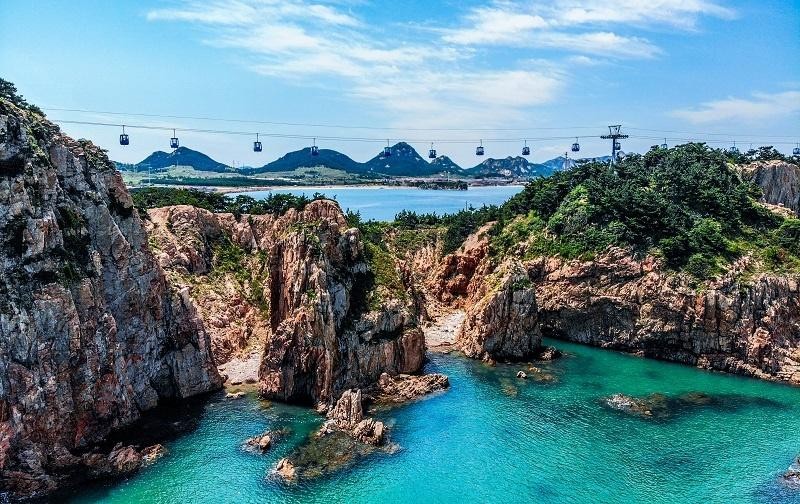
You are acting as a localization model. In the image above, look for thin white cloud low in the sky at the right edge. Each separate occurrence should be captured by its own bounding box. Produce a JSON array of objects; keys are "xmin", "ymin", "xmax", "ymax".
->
[{"xmin": 670, "ymin": 91, "xmax": 800, "ymax": 124}]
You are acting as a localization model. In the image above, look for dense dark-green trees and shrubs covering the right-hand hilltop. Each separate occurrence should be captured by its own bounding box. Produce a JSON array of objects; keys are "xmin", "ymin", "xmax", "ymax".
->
[{"xmin": 378, "ymin": 143, "xmax": 800, "ymax": 279}]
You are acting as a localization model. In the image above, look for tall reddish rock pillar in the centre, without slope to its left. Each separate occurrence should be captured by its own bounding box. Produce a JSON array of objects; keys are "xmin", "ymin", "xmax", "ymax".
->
[{"xmin": 260, "ymin": 202, "xmax": 425, "ymax": 404}]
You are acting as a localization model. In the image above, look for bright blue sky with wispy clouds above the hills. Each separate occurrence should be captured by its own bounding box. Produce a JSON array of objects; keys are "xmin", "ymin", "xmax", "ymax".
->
[{"xmin": 0, "ymin": 0, "xmax": 800, "ymax": 167}]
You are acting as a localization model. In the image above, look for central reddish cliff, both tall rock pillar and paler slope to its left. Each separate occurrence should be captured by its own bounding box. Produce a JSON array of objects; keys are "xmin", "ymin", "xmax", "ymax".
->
[{"xmin": 150, "ymin": 200, "xmax": 425, "ymax": 405}]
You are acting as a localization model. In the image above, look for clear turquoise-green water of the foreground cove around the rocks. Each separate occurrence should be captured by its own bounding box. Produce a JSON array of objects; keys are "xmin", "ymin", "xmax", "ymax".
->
[{"xmin": 69, "ymin": 342, "xmax": 800, "ymax": 504}]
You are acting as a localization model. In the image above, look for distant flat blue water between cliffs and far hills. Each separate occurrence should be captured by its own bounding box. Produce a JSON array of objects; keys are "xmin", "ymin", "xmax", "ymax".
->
[{"xmin": 232, "ymin": 186, "xmax": 522, "ymax": 221}]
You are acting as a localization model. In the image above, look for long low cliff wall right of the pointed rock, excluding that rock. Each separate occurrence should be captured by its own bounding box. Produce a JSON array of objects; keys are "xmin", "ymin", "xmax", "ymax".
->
[{"xmin": 527, "ymin": 249, "xmax": 800, "ymax": 384}]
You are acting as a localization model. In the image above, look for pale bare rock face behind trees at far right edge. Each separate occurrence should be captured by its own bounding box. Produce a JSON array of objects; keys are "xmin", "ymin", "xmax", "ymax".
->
[{"xmin": 739, "ymin": 161, "xmax": 800, "ymax": 215}]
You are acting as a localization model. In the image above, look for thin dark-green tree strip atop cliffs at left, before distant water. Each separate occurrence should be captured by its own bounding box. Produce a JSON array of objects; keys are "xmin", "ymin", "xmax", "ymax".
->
[{"xmin": 131, "ymin": 187, "xmax": 323, "ymax": 216}]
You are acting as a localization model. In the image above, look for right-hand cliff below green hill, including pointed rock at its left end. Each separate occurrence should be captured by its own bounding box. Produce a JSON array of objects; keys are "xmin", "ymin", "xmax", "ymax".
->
[{"xmin": 428, "ymin": 223, "xmax": 800, "ymax": 384}]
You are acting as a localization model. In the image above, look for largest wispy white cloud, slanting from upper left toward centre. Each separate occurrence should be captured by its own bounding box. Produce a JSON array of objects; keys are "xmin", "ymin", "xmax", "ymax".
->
[{"xmin": 148, "ymin": 0, "xmax": 566, "ymax": 127}]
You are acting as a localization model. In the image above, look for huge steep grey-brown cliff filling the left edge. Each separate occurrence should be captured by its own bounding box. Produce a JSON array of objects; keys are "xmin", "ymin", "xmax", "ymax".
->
[{"xmin": 0, "ymin": 99, "xmax": 221, "ymax": 496}]
